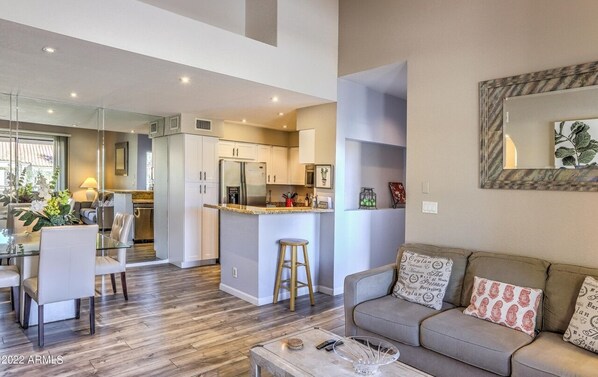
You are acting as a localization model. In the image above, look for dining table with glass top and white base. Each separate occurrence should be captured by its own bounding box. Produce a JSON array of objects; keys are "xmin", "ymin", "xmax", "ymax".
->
[{"xmin": 0, "ymin": 228, "xmax": 130, "ymax": 326}]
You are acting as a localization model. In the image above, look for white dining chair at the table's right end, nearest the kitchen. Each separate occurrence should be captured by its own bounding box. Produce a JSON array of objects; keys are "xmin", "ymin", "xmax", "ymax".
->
[{"xmin": 96, "ymin": 213, "xmax": 133, "ymax": 300}]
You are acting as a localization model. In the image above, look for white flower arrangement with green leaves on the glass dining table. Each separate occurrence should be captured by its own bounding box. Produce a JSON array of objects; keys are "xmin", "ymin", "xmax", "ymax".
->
[{"xmin": 14, "ymin": 169, "xmax": 79, "ymax": 232}]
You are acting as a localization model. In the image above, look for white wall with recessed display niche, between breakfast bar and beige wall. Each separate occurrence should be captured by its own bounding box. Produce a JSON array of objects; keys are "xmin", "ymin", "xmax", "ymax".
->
[{"xmin": 332, "ymin": 79, "xmax": 406, "ymax": 294}]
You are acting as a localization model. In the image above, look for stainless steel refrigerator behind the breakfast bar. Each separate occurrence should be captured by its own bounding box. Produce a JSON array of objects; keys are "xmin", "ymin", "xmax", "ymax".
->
[{"xmin": 220, "ymin": 160, "xmax": 266, "ymax": 206}]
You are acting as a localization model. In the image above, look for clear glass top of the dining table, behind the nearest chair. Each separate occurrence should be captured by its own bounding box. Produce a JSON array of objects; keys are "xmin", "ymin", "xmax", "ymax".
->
[{"xmin": 0, "ymin": 229, "xmax": 129, "ymax": 259}]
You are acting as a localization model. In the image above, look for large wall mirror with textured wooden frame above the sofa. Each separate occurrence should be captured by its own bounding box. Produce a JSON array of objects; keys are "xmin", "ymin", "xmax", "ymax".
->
[{"xmin": 479, "ymin": 62, "xmax": 598, "ymax": 191}]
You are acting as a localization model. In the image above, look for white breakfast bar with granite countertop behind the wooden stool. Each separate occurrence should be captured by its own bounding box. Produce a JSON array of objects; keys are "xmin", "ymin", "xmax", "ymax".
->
[{"xmin": 204, "ymin": 204, "xmax": 334, "ymax": 305}]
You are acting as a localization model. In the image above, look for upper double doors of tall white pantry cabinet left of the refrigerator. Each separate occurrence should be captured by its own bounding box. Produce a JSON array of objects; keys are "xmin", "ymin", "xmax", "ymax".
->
[{"xmin": 183, "ymin": 135, "xmax": 219, "ymax": 182}]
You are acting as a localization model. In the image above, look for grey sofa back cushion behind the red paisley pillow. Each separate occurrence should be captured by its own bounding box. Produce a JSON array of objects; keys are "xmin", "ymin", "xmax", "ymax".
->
[{"xmin": 461, "ymin": 251, "xmax": 549, "ymax": 329}]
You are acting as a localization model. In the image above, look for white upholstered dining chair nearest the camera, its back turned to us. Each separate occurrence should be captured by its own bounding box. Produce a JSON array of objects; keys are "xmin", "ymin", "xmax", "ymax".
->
[{"xmin": 23, "ymin": 225, "xmax": 98, "ymax": 347}]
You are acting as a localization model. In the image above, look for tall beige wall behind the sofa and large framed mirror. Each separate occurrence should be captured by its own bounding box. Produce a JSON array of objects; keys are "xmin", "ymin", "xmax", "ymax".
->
[{"xmin": 339, "ymin": 0, "xmax": 598, "ymax": 267}]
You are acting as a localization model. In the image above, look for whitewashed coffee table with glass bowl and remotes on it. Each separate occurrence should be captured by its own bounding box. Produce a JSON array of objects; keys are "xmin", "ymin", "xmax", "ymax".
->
[{"xmin": 251, "ymin": 327, "xmax": 431, "ymax": 377}]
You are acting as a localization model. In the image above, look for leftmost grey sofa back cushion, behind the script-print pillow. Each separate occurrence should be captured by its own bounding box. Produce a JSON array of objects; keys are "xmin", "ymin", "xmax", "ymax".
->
[{"xmin": 397, "ymin": 243, "xmax": 471, "ymax": 306}]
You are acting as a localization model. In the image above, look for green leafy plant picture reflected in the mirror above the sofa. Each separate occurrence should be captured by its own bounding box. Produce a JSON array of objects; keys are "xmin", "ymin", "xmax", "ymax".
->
[{"xmin": 554, "ymin": 121, "xmax": 598, "ymax": 167}]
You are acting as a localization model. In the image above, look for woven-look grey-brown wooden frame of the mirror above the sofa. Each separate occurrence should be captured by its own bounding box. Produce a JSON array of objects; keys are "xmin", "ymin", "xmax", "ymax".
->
[{"xmin": 479, "ymin": 62, "xmax": 598, "ymax": 191}]
